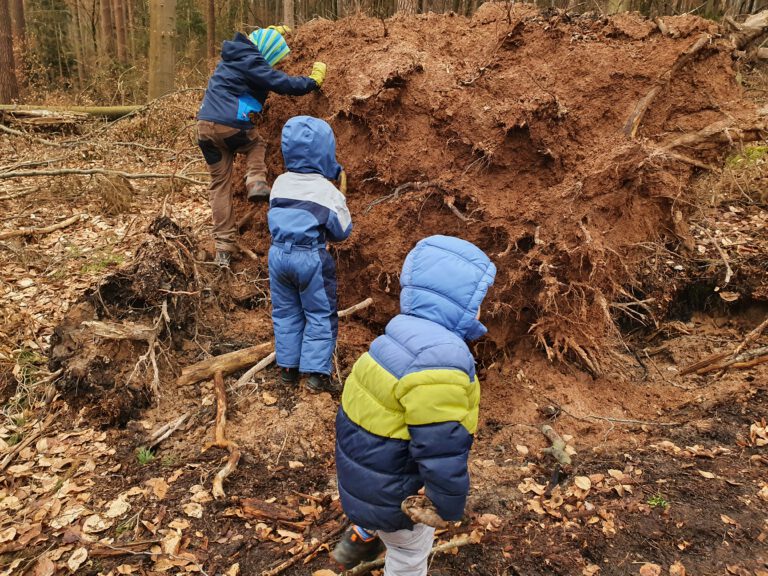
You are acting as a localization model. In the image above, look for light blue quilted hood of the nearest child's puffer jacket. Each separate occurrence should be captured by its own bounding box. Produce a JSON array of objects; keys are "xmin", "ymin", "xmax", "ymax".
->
[{"xmin": 400, "ymin": 236, "xmax": 496, "ymax": 342}]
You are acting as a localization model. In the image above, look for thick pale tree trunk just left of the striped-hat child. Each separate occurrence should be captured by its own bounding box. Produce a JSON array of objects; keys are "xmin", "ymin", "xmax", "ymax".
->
[{"xmin": 149, "ymin": 0, "xmax": 176, "ymax": 100}]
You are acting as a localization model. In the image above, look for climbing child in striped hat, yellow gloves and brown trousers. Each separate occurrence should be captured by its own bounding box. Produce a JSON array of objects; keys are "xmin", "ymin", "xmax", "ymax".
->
[{"xmin": 197, "ymin": 26, "xmax": 326, "ymax": 267}]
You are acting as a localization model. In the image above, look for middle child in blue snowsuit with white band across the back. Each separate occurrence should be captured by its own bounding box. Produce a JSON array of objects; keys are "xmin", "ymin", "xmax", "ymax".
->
[{"xmin": 268, "ymin": 116, "xmax": 352, "ymax": 392}]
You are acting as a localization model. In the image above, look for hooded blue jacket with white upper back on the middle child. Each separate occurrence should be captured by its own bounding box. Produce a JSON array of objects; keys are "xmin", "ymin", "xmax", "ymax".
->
[{"xmin": 267, "ymin": 116, "xmax": 352, "ymax": 246}]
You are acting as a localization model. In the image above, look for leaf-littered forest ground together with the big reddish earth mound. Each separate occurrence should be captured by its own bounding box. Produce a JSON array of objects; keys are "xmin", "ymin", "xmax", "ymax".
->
[{"xmin": 0, "ymin": 5, "xmax": 768, "ymax": 576}]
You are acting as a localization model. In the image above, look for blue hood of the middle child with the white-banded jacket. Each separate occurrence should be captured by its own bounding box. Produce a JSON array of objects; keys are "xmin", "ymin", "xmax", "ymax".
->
[{"xmin": 281, "ymin": 116, "xmax": 341, "ymax": 180}]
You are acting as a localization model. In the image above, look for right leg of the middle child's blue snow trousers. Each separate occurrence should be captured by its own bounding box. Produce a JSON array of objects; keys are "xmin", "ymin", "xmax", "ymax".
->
[{"xmin": 299, "ymin": 246, "xmax": 339, "ymax": 374}]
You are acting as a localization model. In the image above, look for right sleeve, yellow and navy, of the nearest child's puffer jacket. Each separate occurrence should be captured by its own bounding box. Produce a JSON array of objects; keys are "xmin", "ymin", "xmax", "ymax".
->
[{"xmin": 397, "ymin": 350, "xmax": 473, "ymax": 520}]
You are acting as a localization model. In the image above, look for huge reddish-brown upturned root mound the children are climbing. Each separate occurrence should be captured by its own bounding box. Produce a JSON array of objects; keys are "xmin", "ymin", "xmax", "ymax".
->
[{"xmin": 250, "ymin": 3, "xmax": 754, "ymax": 375}]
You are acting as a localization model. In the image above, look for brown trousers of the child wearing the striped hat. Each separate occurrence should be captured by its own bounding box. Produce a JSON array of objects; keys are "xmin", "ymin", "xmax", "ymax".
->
[{"xmin": 197, "ymin": 120, "xmax": 267, "ymax": 252}]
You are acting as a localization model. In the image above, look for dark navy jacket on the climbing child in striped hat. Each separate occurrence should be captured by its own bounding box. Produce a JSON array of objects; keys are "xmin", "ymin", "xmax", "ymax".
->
[{"xmin": 197, "ymin": 32, "xmax": 317, "ymax": 130}]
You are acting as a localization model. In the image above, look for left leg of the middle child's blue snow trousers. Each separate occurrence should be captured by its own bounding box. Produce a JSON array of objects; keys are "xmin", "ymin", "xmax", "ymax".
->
[{"xmin": 268, "ymin": 246, "xmax": 306, "ymax": 368}]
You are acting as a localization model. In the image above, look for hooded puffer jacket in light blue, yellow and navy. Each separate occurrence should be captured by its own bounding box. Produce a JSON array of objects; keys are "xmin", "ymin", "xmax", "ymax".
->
[{"xmin": 336, "ymin": 236, "xmax": 496, "ymax": 531}]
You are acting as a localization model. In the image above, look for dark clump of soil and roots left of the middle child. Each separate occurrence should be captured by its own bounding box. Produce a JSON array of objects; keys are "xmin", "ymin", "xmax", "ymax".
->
[{"xmin": 49, "ymin": 216, "xmax": 216, "ymax": 426}]
